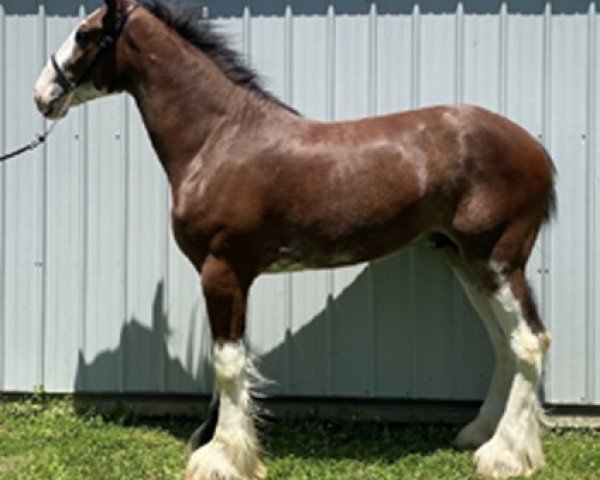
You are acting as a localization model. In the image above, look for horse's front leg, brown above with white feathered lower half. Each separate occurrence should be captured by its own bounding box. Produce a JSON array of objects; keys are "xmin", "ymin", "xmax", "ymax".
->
[{"xmin": 186, "ymin": 257, "xmax": 266, "ymax": 480}]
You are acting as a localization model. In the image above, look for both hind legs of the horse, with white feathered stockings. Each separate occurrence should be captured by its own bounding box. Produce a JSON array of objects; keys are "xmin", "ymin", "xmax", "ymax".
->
[{"xmin": 436, "ymin": 219, "xmax": 550, "ymax": 478}]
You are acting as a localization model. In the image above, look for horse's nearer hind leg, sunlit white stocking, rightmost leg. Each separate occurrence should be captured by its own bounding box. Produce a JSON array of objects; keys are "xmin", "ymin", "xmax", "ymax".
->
[{"xmin": 475, "ymin": 263, "xmax": 550, "ymax": 478}]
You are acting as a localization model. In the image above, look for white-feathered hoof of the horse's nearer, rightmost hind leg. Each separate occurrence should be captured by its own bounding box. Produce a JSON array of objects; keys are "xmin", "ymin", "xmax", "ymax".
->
[{"xmin": 474, "ymin": 437, "xmax": 545, "ymax": 478}]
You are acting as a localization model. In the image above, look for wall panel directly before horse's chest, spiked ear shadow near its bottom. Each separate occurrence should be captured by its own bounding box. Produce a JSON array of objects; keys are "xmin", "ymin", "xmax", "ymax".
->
[{"xmin": 121, "ymin": 99, "xmax": 169, "ymax": 391}]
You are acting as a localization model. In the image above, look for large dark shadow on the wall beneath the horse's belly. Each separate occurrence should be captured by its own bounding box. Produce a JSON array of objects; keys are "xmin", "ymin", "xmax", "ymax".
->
[{"xmin": 259, "ymin": 245, "xmax": 493, "ymax": 400}]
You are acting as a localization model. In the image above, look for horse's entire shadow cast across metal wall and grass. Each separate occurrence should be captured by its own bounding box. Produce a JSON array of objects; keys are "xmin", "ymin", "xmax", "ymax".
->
[{"xmin": 69, "ymin": 249, "xmax": 491, "ymax": 463}]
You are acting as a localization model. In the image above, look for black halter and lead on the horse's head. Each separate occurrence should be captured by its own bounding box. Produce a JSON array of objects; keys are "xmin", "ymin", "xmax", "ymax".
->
[{"xmin": 0, "ymin": 3, "xmax": 139, "ymax": 163}]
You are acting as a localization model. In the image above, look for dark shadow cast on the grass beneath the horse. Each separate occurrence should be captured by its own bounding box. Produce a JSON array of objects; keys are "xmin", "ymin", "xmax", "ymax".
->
[{"xmin": 68, "ymin": 397, "xmax": 459, "ymax": 464}]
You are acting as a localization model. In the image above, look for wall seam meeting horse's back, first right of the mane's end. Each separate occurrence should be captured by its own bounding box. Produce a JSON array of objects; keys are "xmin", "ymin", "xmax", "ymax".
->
[{"xmin": 325, "ymin": 3, "xmax": 336, "ymax": 395}]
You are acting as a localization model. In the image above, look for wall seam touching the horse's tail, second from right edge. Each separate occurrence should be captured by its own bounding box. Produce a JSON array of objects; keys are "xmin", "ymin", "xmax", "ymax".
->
[{"xmin": 541, "ymin": 0, "xmax": 553, "ymax": 401}]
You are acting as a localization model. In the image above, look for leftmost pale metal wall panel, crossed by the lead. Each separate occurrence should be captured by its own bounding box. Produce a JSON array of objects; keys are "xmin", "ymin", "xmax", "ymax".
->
[{"xmin": 4, "ymin": 1, "xmax": 44, "ymax": 389}]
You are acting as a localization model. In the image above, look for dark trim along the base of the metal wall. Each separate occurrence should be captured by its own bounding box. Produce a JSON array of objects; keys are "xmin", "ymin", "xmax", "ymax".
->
[{"xmin": 0, "ymin": 392, "xmax": 600, "ymax": 428}]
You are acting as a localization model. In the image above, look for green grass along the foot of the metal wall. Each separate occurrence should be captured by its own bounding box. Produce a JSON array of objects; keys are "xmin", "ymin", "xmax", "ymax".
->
[{"xmin": 0, "ymin": 397, "xmax": 600, "ymax": 480}]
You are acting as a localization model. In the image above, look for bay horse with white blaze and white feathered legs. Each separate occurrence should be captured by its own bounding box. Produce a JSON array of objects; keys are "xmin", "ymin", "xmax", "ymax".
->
[{"xmin": 34, "ymin": 0, "xmax": 555, "ymax": 480}]
